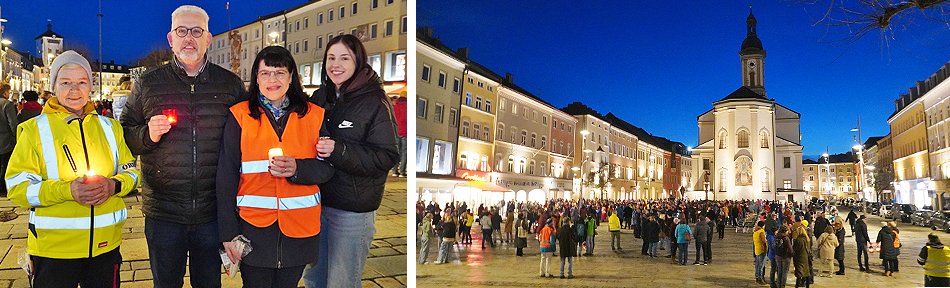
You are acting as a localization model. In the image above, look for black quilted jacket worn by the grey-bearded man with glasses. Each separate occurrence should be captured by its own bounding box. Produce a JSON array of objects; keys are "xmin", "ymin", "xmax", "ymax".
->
[{"xmin": 120, "ymin": 60, "xmax": 245, "ymax": 224}]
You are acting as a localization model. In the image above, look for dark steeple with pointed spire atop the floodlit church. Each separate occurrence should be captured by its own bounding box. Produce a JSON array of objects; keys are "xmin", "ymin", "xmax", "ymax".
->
[{"xmin": 739, "ymin": 6, "xmax": 765, "ymax": 96}]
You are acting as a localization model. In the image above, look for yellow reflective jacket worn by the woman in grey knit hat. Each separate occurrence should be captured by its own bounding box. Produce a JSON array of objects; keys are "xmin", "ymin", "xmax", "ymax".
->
[{"xmin": 5, "ymin": 98, "xmax": 139, "ymax": 259}]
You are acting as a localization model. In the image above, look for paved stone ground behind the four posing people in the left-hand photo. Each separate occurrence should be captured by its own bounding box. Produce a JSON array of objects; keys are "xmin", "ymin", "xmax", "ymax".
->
[{"xmin": 0, "ymin": 177, "xmax": 407, "ymax": 288}]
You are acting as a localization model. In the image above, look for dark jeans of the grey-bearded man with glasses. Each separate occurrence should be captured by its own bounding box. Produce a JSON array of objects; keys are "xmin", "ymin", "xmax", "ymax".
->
[{"xmin": 145, "ymin": 217, "xmax": 223, "ymax": 288}]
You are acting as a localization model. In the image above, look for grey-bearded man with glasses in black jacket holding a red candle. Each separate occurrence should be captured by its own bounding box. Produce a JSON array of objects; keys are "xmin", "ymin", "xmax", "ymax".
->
[{"xmin": 121, "ymin": 5, "xmax": 245, "ymax": 287}]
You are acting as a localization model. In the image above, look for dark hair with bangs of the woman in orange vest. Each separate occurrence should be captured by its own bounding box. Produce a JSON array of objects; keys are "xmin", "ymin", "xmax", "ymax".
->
[{"xmin": 247, "ymin": 46, "xmax": 310, "ymax": 120}]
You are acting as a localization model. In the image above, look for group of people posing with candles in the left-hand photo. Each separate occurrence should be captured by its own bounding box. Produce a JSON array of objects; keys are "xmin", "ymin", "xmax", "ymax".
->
[{"xmin": 0, "ymin": 5, "xmax": 405, "ymax": 287}]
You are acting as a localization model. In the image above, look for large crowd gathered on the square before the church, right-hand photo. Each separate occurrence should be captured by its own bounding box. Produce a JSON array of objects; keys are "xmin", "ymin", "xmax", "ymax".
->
[{"xmin": 416, "ymin": 199, "xmax": 950, "ymax": 287}]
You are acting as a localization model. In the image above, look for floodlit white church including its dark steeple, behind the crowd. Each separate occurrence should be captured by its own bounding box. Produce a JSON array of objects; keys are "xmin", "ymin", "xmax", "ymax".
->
[{"xmin": 688, "ymin": 11, "xmax": 806, "ymax": 201}]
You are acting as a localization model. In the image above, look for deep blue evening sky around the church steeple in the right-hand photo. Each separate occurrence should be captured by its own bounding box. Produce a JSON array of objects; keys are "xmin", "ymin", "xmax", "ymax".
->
[{"xmin": 416, "ymin": 0, "xmax": 950, "ymax": 158}]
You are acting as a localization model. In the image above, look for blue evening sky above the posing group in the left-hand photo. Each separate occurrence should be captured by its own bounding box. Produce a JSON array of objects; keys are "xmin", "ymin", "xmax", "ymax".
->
[{"xmin": 0, "ymin": 0, "xmax": 306, "ymax": 64}]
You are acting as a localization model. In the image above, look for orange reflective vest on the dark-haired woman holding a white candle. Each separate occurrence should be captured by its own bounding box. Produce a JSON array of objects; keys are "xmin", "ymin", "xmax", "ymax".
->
[{"xmin": 231, "ymin": 101, "xmax": 324, "ymax": 238}]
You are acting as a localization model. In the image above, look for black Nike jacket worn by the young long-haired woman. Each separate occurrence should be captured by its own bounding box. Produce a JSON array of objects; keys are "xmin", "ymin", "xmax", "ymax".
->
[{"xmin": 310, "ymin": 66, "xmax": 399, "ymax": 213}]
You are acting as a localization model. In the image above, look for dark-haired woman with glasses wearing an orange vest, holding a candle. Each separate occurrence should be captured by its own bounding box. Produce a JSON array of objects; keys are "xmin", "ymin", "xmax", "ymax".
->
[{"xmin": 217, "ymin": 46, "xmax": 333, "ymax": 287}]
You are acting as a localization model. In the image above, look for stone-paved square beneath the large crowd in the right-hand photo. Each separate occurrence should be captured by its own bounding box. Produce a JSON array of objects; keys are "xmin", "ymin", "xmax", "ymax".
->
[{"xmin": 412, "ymin": 208, "xmax": 936, "ymax": 287}]
